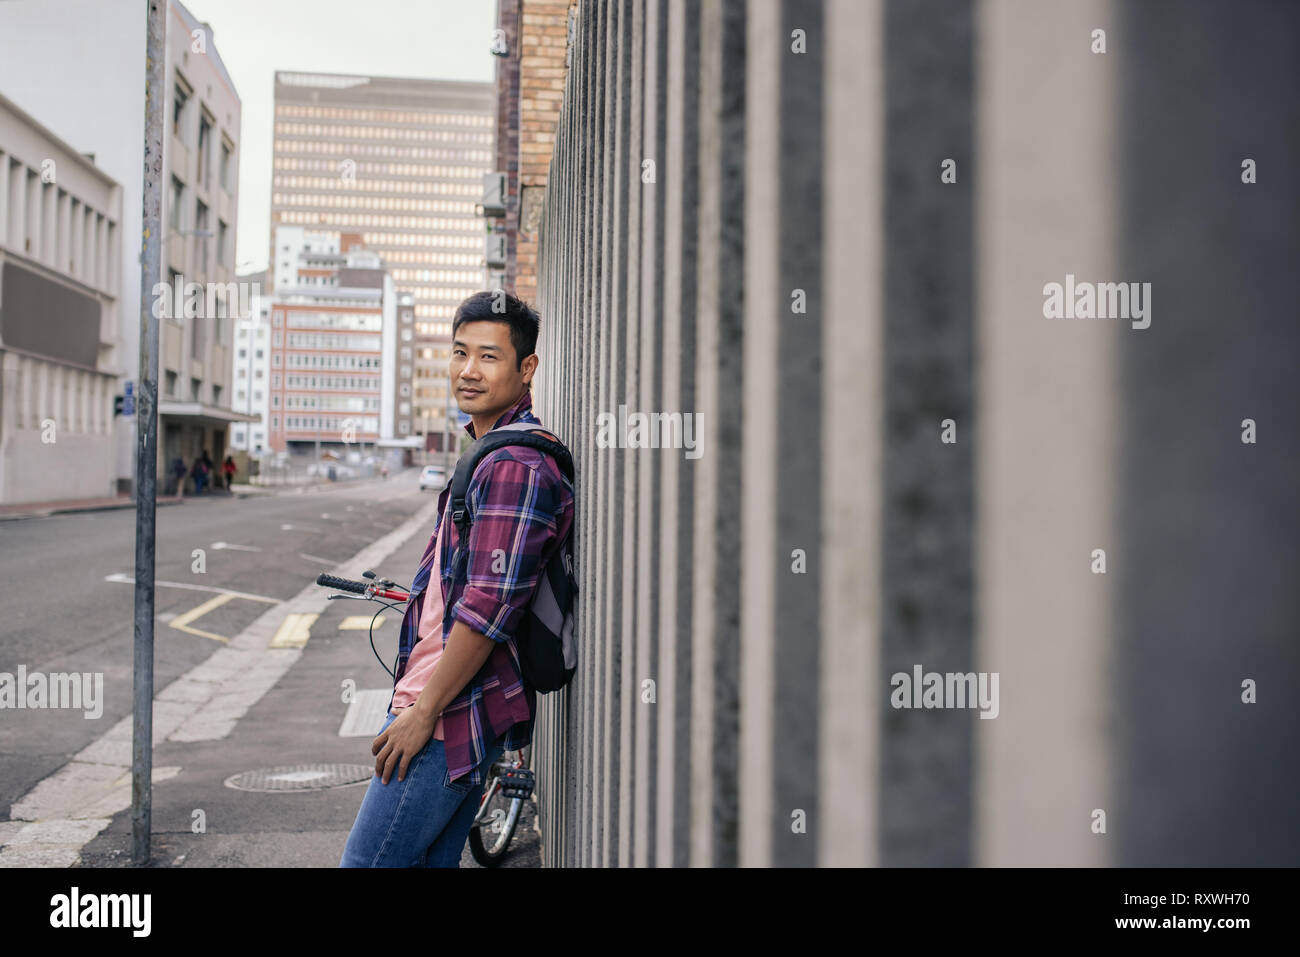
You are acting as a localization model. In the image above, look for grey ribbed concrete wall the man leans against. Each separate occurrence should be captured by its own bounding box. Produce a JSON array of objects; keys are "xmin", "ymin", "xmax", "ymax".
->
[{"xmin": 534, "ymin": 0, "xmax": 1300, "ymax": 866}]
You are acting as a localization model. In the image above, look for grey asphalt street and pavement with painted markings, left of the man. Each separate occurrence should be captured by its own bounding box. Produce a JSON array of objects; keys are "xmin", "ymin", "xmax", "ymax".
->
[{"xmin": 0, "ymin": 469, "xmax": 538, "ymax": 866}]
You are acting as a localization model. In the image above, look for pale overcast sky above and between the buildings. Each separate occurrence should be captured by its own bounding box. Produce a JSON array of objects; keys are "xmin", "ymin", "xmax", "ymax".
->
[{"xmin": 181, "ymin": 0, "xmax": 497, "ymax": 273}]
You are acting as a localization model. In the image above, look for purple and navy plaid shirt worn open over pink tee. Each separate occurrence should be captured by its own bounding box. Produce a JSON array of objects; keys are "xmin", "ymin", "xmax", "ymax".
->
[{"xmin": 389, "ymin": 390, "xmax": 573, "ymax": 785}]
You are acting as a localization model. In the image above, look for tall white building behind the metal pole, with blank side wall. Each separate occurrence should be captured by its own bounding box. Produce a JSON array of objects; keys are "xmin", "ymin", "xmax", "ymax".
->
[{"xmin": 0, "ymin": 0, "xmax": 252, "ymax": 490}]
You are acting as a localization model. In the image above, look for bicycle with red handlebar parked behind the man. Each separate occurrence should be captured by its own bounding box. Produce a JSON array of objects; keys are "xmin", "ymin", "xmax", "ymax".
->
[{"xmin": 316, "ymin": 571, "xmax": 537, "ymax": 867}]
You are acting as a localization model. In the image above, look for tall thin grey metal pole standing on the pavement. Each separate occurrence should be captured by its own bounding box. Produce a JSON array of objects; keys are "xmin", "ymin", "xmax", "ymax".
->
[{"xmin": 131, "ymin": 0, "xmax": 166, "ymax": 866}]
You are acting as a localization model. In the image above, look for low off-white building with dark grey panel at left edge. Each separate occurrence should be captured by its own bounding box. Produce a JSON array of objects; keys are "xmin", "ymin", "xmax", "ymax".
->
[{"xmin": 0, "ymin": 95, "xmax": 124, "ymax": 505}]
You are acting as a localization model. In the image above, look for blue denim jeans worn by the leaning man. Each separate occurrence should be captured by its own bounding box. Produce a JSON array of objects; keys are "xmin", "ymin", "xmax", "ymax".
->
[{"xmin": 338, "ymin": 714, "xmax": 504, "ymax": 867}]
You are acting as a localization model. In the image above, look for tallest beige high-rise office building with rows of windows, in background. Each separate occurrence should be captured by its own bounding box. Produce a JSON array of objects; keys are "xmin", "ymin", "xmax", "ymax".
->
[{"xmin": 272, "ymin": 73, "xmax": 497, "ymax": 449}]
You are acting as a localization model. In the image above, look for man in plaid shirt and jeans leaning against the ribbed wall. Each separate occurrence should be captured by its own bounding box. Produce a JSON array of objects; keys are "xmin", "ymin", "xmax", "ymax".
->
[{"xmin": 339, "ymin": 293, "xmax": 573, "ymax": 867}]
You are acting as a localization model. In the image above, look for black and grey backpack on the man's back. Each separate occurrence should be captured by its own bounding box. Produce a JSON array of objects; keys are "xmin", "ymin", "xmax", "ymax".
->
[{"xmin": 450, "ymin": 423, "xmax": 577, "ymax": 694}]
